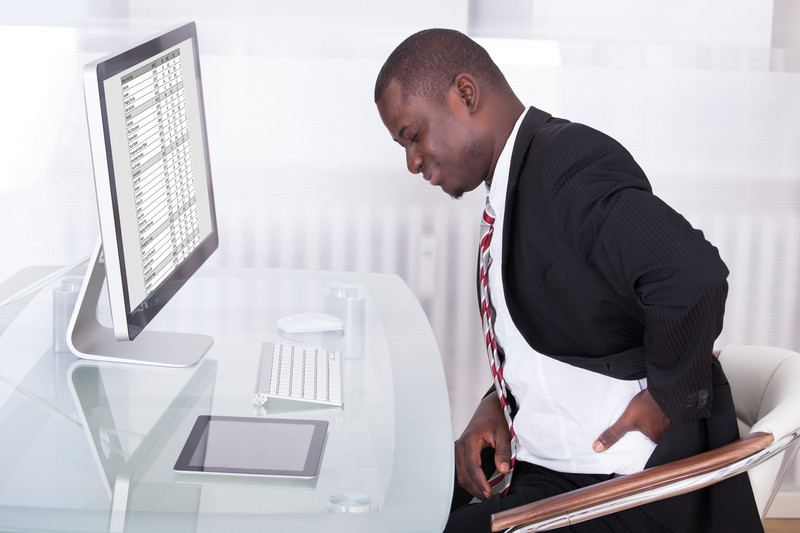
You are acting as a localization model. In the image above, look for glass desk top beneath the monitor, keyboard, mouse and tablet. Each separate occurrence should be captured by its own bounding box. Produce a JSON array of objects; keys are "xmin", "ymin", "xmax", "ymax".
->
[{"xmin": 0, "ymin": 269, "xmax": 453, "ymax": 532}]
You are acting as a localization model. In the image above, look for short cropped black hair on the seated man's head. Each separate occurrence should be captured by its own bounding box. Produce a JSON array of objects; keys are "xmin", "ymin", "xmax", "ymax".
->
[{"xmin": 375, "ymin": 28, "xmax": 511, "ymax": 103}]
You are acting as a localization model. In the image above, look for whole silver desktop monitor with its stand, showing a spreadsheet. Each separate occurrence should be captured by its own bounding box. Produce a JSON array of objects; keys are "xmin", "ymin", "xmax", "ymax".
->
[{"xmin": 67, "ymin": 23, "xmax": 219, "ymax": 366}]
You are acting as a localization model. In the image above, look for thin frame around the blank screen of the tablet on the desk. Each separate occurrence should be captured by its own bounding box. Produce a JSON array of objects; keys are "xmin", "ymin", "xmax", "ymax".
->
[{"xmin": 173, "ymin": 415, "xmax": 328, "ymax": 479}]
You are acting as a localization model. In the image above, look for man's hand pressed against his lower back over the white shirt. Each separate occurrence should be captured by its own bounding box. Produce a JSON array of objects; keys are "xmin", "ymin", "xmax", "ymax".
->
[{"xmin": 592, "ymin": 389, "xmax": 671, "ymax": 452}]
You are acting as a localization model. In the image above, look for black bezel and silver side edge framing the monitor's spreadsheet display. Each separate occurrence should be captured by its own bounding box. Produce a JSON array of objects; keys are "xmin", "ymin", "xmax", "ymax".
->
[{"xmin": 85, "ymin": 22, "xmax": 219, "ymax": 340}]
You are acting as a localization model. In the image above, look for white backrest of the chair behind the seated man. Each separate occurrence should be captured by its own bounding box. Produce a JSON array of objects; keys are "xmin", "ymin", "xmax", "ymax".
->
[{"xmin": 719, "ymin": 346, "xmax": 800, "ymax": 518}]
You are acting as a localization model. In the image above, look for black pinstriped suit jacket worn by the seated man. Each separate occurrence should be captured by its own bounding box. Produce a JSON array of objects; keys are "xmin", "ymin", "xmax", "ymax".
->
[{"xmin": 488, "ymin": 108, "xmax": 760, "ymax": 531}]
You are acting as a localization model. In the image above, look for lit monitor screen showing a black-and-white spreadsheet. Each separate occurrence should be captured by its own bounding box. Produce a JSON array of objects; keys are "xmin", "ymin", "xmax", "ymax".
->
[{"xmin": 100, "ymin": 38, "xmax": 214, "ymax": 320}]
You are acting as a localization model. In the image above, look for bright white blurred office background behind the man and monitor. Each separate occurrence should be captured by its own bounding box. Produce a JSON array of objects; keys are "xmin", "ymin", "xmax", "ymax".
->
[{"xmin": 0, "ymin": 0, "xmax": 800, "ymax": 516}]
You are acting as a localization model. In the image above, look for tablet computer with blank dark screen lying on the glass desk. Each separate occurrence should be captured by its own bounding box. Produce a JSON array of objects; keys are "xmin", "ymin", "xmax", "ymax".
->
[{"xmin": 174, "ymin": 415, "xmax": 328, "ymax": 479}]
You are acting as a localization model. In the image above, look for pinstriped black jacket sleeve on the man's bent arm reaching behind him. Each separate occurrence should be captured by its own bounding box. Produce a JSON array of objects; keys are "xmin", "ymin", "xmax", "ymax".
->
[{"xmin": 542, "ymin": 124, "xmax": 728, "ymax": 421}]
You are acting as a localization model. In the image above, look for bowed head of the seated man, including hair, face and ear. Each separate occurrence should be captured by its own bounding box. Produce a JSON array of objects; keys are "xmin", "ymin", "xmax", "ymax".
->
[{"xmin": 375, "ymin": 29, "xmax": 523, "ymax": 198}]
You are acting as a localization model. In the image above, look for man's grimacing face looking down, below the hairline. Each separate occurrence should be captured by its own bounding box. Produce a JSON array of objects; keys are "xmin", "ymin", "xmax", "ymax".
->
[{"xmin": 378, "ymin": 80, "xmax": 491, "ymax": 198}]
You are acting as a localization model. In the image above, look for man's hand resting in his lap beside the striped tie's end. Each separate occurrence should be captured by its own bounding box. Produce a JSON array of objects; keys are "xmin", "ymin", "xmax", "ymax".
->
[{"xmin": 455, "ymin": 393, "xmax": 511, "ymax": 500}]
